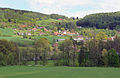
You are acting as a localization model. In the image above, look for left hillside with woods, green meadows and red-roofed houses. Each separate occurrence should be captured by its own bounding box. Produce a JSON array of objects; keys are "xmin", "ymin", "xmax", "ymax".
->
[{"xmin": 0, "ymin": 8, "xmax": 76, "ymax": 46}]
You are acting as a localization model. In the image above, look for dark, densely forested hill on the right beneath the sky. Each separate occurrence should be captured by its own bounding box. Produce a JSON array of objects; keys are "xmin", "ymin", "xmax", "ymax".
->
[{"xmin": 77, "ymin": 12, "xmax": 120, "ymax": 29}]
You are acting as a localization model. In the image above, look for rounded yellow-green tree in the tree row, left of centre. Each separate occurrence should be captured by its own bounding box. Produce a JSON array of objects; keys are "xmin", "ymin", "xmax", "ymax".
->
[{"xmin": 35, "ymin": 38, "xmax": 52, "ymax": 66}]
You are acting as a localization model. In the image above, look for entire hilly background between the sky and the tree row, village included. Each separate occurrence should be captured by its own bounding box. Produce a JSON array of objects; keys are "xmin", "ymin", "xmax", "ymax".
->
[{"xmin": 0, "ymin": 8, "xmax": 120, "ymax": 46}]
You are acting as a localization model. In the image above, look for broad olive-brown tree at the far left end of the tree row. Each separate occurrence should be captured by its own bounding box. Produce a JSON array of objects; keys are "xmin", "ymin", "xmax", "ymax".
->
[{"xmin": 0, "ymin": 40, "xmax": 18, "ymax": 66}]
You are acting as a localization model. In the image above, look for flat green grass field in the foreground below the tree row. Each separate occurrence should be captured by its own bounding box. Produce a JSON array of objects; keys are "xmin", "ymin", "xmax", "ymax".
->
[{"xmin": 0, "ymin": 66, "xmax": 120, "ymax": 78}]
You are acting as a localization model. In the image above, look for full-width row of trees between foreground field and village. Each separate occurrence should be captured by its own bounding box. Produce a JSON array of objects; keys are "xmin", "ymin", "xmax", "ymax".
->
[{"xmin": 0, "ymin": 37, "xmax": 120, "ymax": 67}]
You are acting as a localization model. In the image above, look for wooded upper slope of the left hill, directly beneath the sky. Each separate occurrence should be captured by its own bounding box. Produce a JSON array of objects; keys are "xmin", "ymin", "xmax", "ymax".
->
[{"xmin": 0, "ymin": 8, "xmax": 67, "ymax": 24}]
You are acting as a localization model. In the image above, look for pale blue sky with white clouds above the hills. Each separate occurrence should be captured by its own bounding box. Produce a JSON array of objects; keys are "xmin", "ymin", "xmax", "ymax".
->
[{"xmin": 0, "ymin": 0, "xmax": 120, "ymax": 18}]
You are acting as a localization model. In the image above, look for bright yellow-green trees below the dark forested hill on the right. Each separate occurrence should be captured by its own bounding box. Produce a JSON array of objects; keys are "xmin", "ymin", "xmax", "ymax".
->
[{"xmin": 78, "ymin": 28, "xmax": 117, "ymax": 40}]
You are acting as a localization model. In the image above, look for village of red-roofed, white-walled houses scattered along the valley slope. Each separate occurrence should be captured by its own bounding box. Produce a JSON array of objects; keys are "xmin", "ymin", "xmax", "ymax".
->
[{"xmin": 14, "ymin": 25, "xmax": 115, "ymax": 42}]
